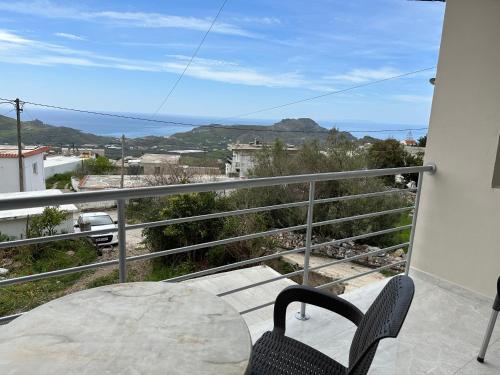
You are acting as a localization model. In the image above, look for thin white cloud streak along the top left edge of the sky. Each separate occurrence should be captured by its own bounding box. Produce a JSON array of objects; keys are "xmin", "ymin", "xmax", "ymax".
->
[{"xmin": 0, "ymin": 0, "xmax": 256, "ymax": 37}]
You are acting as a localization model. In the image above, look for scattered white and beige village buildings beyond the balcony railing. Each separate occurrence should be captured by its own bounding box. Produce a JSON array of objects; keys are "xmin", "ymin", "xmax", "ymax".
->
[{"xmin": 0, "ymin": 139, "xmax": 425, "ymax": 239}]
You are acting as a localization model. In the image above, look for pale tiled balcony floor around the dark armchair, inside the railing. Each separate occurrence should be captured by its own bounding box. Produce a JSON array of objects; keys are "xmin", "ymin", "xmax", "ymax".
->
[{"xmin": 250, "ymin": 272, "xmax": 500, "ymax": 375}]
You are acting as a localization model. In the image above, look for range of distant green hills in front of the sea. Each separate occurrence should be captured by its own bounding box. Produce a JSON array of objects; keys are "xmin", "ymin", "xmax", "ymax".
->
[{"xmin": 0, "ymin": 116, "xmax": 376, "ymax": 152}]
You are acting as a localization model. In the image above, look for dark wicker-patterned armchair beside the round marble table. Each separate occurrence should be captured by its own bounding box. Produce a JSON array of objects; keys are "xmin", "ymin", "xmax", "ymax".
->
[{"xmin": 251, "ymin": 275, "xmax": 415, "ymax": 375}]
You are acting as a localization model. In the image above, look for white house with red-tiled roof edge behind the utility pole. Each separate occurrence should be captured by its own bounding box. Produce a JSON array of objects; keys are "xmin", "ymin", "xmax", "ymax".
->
[{"xmin": 0, "ymin": 146, "xmax": 49, "ymax": 193}]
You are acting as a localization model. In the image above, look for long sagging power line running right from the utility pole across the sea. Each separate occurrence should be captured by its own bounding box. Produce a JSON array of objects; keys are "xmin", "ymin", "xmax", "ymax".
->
[{"xmin": 0, "ymin": 98, "xmax": 427, "ymax": 134}]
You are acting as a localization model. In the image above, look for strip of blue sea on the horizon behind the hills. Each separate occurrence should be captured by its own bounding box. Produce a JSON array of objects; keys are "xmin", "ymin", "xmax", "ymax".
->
[{"xmin": 9, "ymin": 108, "xmax": 427, "ymax": 139}]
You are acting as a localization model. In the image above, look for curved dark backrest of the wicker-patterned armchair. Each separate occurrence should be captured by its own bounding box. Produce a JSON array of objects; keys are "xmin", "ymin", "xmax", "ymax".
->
[{"xmin": 348, "ymin": 275, "xmax": 415, "ymax": 375}]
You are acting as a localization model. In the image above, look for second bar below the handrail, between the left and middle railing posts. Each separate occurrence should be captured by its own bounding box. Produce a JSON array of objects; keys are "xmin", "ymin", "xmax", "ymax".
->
[{"xmin": 127, "ymin": 224, "xmax": 307, "ymax": 262}]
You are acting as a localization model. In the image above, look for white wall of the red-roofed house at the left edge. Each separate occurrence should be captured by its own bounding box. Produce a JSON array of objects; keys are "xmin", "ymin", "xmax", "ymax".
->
[{"xmin": 0, "ymin": 153, "xmax": 45, "ymax": 193}]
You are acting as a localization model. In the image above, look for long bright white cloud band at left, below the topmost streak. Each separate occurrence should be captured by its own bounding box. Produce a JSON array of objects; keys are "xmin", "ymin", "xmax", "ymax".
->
[{"xmin": 0, "ymin": 29, "xmax": 312, "ymax": 87}]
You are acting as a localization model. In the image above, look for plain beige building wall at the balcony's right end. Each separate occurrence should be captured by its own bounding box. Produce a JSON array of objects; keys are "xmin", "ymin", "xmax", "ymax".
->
[{"xmin": 412, "ymin": 0, "xmax": 500, "ymax": 297}]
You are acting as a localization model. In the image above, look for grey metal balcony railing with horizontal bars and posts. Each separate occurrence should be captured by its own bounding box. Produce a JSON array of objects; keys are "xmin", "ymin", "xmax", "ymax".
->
[{"xmin": 0, "ymin": 165, "xmax": 436, "ymax": 324}]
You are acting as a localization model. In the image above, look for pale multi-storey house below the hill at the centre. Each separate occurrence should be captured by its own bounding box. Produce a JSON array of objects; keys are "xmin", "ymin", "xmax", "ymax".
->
[{"xmin": 226, "ymin": 141, "xmax": 299, "ymax": 177}]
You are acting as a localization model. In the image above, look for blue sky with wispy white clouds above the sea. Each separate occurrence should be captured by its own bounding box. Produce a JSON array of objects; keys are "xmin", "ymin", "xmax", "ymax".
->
[{"xmin": 0, "ymin": 0, "xmax": 444, "ymax": 126}]
